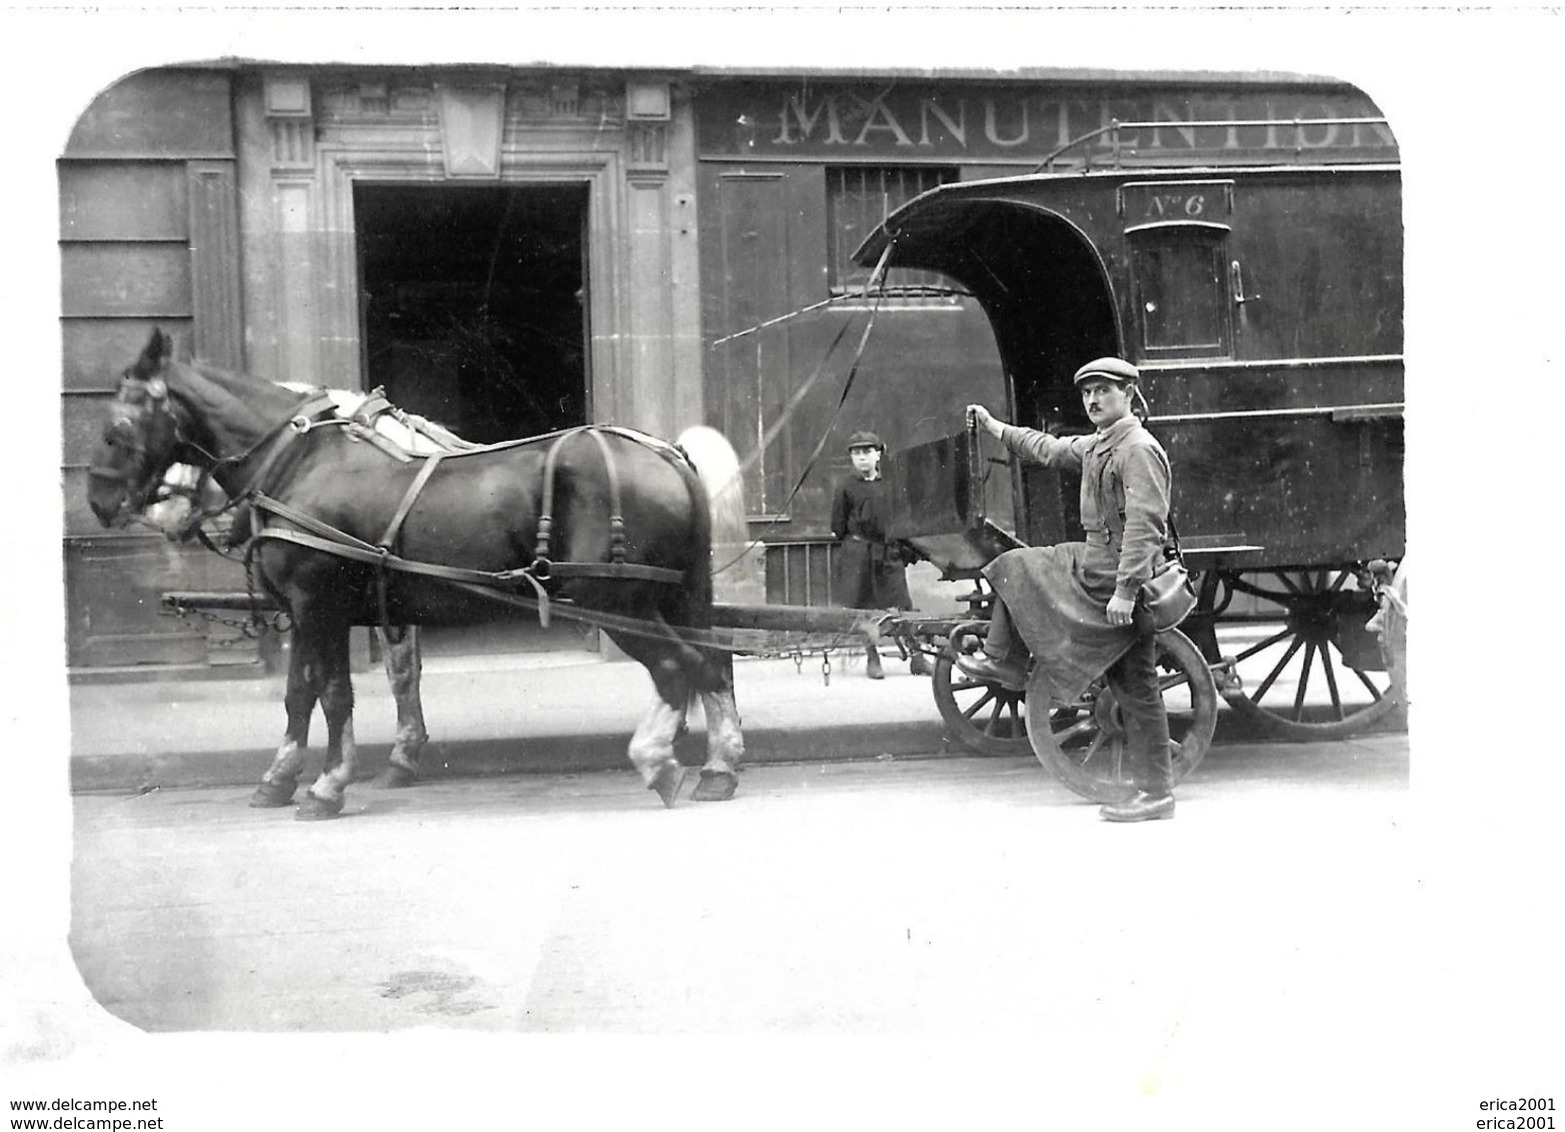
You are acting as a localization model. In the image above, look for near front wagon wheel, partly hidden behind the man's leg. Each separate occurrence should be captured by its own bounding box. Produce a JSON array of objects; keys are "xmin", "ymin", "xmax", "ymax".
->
[{"xmin": 1027, "ymin": 629, "xmax": 1218, "ymax": 802}]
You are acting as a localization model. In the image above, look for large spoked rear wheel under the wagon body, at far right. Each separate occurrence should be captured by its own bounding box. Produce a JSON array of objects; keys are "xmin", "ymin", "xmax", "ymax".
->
[{"xmin": 1193, "ymin": 567, "xmax": 1402, "ymax": 741}]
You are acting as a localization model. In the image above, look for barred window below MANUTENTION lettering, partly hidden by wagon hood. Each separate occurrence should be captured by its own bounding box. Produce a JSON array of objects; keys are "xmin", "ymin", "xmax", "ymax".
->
[{"xmin": 826, "ymin": 164, "xmax": 958, "ymax": 299}]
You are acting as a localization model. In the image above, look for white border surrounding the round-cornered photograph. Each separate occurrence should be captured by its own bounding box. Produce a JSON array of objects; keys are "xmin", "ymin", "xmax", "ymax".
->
[{"xmin": 0, "ymin": 11, "xmax": 1539, "ymax": 1132}]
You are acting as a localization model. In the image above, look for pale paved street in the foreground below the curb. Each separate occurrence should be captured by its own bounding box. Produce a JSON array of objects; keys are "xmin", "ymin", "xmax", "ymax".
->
[{"xmin": 70, "ymin": 736, "xmax": 1410, "ymax": 1033}]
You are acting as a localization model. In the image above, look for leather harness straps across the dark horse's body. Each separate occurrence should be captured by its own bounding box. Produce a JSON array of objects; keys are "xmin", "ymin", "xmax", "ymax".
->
[{"xmin": 238, "ymin": 396, "xmax": 685, "ymax": 633}]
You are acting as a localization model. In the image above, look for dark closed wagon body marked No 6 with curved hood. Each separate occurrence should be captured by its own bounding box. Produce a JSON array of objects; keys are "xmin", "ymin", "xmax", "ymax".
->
[{"xmin": 859, "ymin": 155, "xmax": 1405, "ymax": 568}]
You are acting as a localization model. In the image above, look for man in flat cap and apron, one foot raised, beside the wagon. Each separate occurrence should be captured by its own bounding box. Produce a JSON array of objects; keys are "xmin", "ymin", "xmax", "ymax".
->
[{"xmin": 958, "ymin": 357, "xmax": 1174, "ymax": 822}]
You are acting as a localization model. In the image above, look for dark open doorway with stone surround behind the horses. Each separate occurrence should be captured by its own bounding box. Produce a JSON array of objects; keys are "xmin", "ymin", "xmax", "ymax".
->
[{"xmin": 354, "ymin": 183, "xmax": 596, "ymax": 656}]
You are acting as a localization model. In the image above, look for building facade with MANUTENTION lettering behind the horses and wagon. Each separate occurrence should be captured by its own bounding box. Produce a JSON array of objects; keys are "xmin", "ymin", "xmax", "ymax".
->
[{"xmin": 59, "ymin": 64, "xmax": 1394, "ymax": 669}]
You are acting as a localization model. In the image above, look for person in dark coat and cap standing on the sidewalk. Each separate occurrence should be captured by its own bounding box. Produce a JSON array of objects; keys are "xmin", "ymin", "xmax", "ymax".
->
[{"xmin": 831, "ymin": 432, "xmax": 930, "ymax": 680}]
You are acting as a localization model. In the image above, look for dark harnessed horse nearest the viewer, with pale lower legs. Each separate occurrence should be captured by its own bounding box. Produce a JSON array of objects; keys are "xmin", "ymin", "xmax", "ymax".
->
[{"xmin": 88, "ymin": 329, "xmax": 743, "ymax": 820}]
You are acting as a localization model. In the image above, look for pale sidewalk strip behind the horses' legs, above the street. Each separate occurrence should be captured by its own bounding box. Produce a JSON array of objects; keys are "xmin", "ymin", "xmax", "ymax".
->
[{"xmin": 70, "ymin": 653, "xmax": 966, "ymax": 791}]
